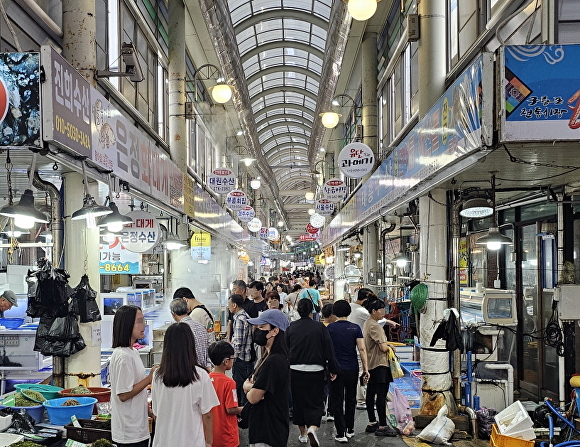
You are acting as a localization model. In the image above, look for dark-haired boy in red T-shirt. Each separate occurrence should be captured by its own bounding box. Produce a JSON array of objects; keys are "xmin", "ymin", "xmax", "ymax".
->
[{"xmin": 207, "ymin": 341, "xmax": 243, "ymax": 447}]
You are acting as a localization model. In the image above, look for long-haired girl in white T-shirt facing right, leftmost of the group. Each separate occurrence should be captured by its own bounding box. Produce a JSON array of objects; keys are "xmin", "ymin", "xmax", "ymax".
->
[{"xmin": 109, "ymin": 306, "xmax": 154, "ymax": 447}]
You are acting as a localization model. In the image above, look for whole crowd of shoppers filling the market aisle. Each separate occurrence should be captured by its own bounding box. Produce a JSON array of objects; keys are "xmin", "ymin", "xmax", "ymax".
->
[{"xmin": 110, "ymin": 275, "xmax": 404, "ymax": 447}]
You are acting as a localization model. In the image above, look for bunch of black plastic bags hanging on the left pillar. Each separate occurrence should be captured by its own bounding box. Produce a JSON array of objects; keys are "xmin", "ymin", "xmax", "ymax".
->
[{"xmin": 26, "ymin": 258, "xmax": 101, "ymax": 357}]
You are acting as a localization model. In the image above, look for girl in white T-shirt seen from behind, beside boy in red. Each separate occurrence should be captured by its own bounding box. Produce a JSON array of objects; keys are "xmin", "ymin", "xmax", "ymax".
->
[{"xmin": 151, "ymin": 323, "xmax": 219, "ymax": 447}]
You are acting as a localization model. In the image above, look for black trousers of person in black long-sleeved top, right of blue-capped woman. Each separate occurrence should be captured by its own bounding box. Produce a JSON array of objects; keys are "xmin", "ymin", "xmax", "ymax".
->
[{"xmin": 290, "ymin": 369, "xmax": 324, "ymax": 427}]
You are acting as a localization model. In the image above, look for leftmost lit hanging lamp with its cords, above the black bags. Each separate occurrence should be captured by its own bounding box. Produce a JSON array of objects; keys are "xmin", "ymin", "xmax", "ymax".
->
[{"xmin": 0, "ymin": 152, "xmax": 48, "ymax": 230}]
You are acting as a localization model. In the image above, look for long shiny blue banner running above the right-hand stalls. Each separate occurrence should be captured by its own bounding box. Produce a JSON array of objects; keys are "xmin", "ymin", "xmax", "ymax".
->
[{"xmin": 322, "ymin": 53, "xmax": 493, "ymax": 246}]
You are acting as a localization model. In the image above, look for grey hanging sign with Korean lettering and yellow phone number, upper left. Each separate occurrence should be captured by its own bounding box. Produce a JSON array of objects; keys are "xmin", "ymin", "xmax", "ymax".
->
[{"xmin": 40, "ymin": 46, "xmax": 92, "ymax": 159}]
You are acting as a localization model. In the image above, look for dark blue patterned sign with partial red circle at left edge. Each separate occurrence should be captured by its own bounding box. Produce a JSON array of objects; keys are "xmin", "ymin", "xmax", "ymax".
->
[{"xmin": 0, "ymin": 53, "xmax": 42, "ymax": 147}]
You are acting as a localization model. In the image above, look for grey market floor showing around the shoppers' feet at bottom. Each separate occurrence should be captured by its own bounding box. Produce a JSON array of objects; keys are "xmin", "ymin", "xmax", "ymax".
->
[{"xmin": 240, "ymin": 410, "xmax": 489, "ymax": 447}]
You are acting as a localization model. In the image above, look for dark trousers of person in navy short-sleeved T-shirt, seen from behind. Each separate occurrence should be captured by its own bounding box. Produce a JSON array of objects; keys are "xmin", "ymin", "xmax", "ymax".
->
[{"xmin": 330, "ymin": 370, "xmax": 358, "ymax": 435}]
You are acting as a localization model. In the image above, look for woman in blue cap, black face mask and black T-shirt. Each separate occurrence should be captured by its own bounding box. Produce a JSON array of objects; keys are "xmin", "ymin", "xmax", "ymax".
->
[{"xmin": 244, "ymin": 309, "xmax": 290, "ymax": 447}]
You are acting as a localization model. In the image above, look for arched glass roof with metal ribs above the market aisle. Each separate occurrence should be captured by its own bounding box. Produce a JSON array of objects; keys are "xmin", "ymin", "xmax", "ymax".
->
[{"xmin": 227, "ymin": 0, "xmax": 332, "ymax": 194}]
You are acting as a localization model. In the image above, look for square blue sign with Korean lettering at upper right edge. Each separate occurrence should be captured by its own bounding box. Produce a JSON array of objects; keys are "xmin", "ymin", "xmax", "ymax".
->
[{"xmin": 500, "ymin": 45, "xmax": 580, "ymax": 141}]
